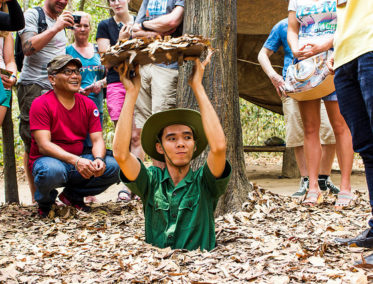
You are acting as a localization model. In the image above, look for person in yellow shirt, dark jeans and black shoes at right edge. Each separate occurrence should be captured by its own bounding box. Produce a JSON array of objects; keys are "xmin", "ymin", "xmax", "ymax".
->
[{"xmin": 334, "ymin": 0, "xmax": 373, "ymax": 264}]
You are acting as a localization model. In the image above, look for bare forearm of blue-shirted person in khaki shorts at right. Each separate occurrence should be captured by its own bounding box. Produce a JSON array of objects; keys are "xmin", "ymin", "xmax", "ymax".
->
[{"xmin": 258, "ymin": 46, "xmax": 286, "ymax": 97}]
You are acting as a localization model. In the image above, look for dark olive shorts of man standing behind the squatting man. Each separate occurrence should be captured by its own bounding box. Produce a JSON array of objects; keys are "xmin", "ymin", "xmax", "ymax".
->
[{"xmin": 17, "ymin": 84, "xmax": 48, "ymax": 153}]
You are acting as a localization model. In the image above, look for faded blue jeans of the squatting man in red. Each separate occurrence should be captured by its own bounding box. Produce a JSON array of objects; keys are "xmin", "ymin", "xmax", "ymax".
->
[{"xmin": 32, "ymin": 154, "xmax": 119, "ymax": 207}]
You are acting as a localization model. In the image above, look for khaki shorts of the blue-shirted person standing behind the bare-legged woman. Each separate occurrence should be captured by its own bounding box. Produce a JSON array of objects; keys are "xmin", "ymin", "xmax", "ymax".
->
[{"xmin": 282, "ymin": 97, "xmax": 335, "ymax": 147}]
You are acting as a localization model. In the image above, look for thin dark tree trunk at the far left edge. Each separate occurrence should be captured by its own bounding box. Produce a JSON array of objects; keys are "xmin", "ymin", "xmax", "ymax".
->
[{"xmin": 2, "ymin": 101, "xmax": 19, "ymax": 203}]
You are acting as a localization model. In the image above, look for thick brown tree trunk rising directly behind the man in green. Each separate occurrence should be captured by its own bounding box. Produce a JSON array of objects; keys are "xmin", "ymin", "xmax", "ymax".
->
[{"xmin": 177, "ymin": 0, "xmax": 251, "ymax": 215}]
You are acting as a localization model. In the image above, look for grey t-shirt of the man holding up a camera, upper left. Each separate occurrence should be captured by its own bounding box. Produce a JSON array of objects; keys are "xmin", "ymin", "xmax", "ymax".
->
[{"xmin": 18, "ymin": 9, "xmax": 67, "ymax": 90}]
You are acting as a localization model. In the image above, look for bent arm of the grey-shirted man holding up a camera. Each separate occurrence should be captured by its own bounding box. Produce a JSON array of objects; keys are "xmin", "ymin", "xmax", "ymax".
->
[{"xmin": 20, "ymin": 11, "xmax": 74, "ymax": 56}]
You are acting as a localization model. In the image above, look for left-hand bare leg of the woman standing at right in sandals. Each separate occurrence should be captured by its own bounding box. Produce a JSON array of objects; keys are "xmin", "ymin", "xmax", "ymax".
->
[{"xmin": 299, "ymin": 100, "xmax": 321, "ymax": 197}]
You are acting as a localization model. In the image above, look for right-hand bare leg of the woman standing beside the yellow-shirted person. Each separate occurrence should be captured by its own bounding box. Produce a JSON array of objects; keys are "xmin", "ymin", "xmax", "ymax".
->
[{"xmin": 325, "ymin": 101, "xmax": 354, "ymax": 193}]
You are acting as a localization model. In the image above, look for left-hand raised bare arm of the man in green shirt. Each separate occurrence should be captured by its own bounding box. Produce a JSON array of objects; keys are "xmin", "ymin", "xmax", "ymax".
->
[{"xmin": 113, "ymin": 63, "xmax": 140, "ymax": 181}]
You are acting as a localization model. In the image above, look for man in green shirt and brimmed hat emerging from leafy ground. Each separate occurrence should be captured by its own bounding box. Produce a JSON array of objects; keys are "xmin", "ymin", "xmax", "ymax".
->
[{"xmin": 113, "ymin": 51, "xmax": 231, "ymax": 250}]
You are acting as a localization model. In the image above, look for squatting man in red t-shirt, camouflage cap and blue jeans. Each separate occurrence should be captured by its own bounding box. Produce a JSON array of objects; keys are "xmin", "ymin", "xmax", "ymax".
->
[{"xmin": 29, "ymin": 55, "xmax": 119, "ymax": 217}]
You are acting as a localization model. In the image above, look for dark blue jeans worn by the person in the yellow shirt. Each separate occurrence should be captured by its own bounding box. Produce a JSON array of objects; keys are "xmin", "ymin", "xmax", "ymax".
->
[{"xmin": 334, "ymin": 52, "xmax": 373, "ymax": 233}]
